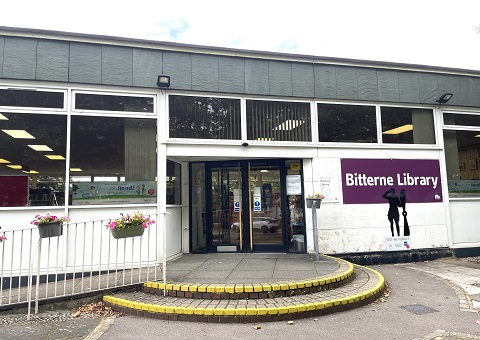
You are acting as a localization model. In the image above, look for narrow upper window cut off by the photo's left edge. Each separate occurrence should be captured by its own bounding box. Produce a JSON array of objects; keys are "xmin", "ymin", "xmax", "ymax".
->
[{"xmin": 0, "ymin": 89, "xmax": 64, "ymax": 109}]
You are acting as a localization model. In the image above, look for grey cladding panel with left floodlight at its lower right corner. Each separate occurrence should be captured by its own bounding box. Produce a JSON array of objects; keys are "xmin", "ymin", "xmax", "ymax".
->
[{"xmin": 133, "ymin": 48, "xmax": 163, "ymax": 87}]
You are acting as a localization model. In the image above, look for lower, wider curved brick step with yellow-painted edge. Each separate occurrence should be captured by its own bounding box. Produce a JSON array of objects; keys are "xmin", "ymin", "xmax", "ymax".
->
[{"xmin": 103, "ymin": 265, "xmax": 384, "ymax": 323}]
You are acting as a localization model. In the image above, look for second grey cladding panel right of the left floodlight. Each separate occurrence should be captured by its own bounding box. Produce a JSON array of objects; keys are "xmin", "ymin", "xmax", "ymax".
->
[{"xmin": 192, "ymin": 54, "xmax": 218, "ymax": 92}]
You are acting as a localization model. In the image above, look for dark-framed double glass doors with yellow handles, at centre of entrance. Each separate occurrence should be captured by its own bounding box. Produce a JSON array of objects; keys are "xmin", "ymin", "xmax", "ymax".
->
[{"xmin": 206, "ymin": 161, "xmax": 289, "ymax": 252}]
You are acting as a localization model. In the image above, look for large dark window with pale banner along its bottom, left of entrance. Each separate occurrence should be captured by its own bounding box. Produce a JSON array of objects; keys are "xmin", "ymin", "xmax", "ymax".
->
[{"xmin": 70, "ymin": 116, "xmax": 157, "ymax": 205}]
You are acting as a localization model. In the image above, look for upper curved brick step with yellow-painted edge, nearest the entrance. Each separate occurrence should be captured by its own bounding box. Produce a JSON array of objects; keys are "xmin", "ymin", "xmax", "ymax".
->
[{"xmin": 143, "ymin": 259, "xmax": 354, "ymax": 300}]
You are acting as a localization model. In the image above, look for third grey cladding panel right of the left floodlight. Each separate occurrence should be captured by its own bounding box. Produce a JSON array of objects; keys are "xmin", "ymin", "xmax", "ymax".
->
[{"xmin": 218, "ymin": 57, "xmax": 245, "ymax": 93}]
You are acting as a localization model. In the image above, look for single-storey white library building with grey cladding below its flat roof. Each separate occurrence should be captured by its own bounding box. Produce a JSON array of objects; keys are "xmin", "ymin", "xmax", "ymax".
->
[{"xmin": 0, "ymin": 27, "xmax": 480, "ymax": 257}]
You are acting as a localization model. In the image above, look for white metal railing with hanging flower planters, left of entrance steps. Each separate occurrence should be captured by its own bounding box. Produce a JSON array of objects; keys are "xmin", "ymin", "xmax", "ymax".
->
[{"xmin": 0, "ymin": 214, "xmax": 165, "ymax": 315}]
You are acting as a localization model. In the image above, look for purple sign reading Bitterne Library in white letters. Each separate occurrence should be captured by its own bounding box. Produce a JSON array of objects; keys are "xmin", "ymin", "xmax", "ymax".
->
[{"xmin": 341, "ymin": 159, "xmax": 443, "ymax": 204}]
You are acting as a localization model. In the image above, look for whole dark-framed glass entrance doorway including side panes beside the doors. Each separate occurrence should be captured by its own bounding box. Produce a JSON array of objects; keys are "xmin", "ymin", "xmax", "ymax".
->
[{"xmin": 191, "ymin": 160, "xmax": 305, "ymax": 252}]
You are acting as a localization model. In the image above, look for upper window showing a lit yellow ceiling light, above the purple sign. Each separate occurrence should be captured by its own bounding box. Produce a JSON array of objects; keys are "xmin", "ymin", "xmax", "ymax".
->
[{"xmin": 380, "ymin": 106, "xmax": 435, "ymax": 144}]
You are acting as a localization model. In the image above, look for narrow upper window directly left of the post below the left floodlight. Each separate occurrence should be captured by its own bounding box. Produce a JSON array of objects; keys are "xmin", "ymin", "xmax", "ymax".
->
[{"xmin": 75, "ymin": 93, "xmax": 153, "ymax": 113}]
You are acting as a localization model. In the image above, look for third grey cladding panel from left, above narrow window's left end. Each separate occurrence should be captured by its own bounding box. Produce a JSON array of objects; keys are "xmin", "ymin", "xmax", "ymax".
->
[{"xmin": 69, "ymin": 43, "xmax": 102, "ymax": 84}]
